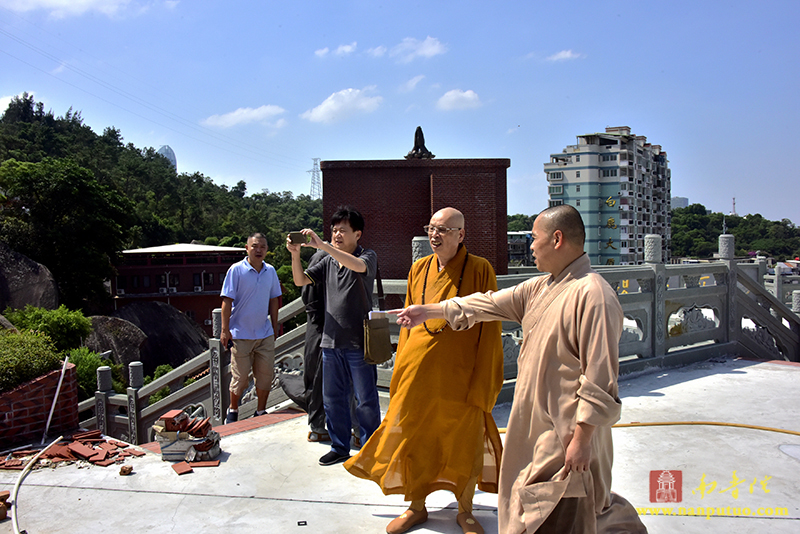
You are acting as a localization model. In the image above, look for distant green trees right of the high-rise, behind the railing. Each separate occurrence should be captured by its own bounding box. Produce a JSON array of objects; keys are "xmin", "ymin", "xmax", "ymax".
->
[{"xmin": 672, "ymin": 204, "xmax": 800, "ymax": 261}]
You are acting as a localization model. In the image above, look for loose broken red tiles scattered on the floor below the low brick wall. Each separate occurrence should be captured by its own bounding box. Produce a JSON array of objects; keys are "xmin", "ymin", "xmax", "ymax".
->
[{"xmin": 0, "ymin": 430, "xmax": 145, "ymax": 470}]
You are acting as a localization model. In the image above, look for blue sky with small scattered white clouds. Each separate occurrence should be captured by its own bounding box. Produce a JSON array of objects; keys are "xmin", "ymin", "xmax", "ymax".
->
[{"xmin": 0, "ymin": 0, "xmax": 800, "ymax": 224}]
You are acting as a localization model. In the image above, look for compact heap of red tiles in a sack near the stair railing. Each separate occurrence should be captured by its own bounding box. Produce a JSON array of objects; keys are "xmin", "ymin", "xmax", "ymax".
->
[{"xmin": 153, "ymin": 410, "xmax": 222, "ymax": 462}]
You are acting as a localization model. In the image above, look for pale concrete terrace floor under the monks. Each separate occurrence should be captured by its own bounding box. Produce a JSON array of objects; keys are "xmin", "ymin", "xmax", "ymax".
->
[{"xmin": 0, "ymin": 359, "xmax": 800, "ymax": 534}]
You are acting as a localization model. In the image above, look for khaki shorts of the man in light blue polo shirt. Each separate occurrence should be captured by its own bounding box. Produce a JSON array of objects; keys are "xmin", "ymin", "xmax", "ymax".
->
[{"xmin": 230, "ymin": 336, "xmax": 275, "ymax": 396}]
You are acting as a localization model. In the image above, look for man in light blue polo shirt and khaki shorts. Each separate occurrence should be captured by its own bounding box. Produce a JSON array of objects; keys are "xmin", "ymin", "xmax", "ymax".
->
[{"xmin": 220, "ymin": 233, "xmax": 282, "ymax": 423}]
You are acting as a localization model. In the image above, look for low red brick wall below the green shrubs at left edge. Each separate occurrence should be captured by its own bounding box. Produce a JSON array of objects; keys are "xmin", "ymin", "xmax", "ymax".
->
[{"xmin": 0, "ymin": 363, "xmax": 79, "ymax": 449}]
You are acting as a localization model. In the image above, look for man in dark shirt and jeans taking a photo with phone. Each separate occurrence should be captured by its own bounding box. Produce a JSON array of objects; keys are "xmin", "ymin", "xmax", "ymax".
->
[{"xmin": 286, "ymin": 206, "xmax": 381, "ymax": 465}]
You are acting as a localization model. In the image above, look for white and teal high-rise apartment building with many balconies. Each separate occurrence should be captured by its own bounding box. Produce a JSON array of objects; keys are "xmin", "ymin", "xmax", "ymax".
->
[{"xmin": 544, "ymin": 126, "xmax": 671, "ymax": 265}]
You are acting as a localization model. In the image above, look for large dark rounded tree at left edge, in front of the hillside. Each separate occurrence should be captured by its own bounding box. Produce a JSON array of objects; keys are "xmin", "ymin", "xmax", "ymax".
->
[{"xmin": 0, "ymin": 158, "xmax": 131, "ymax": 309}]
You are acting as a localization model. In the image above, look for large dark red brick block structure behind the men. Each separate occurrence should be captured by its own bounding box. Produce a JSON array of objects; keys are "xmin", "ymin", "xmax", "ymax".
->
[{"xmin": 320, "ymin": 159, "xmax": 511, "ymax": 279}]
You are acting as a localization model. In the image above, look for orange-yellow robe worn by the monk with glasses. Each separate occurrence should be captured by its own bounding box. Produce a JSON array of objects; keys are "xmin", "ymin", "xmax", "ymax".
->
[{"xmin": 344, "ymin": 246, "xmax": 503, "ymax": 501}]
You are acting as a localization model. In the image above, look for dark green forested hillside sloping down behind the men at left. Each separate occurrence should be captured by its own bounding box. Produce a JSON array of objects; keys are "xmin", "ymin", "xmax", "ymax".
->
[{"xmin": 0, "ymin": 94, "xmax": 322, "ymax": 312}]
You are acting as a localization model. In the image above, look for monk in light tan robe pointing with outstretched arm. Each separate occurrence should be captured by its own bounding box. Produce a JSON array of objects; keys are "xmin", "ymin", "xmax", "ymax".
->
[{"xmin": 398, "ymin": 204, "xmax": 647, "ymax": 534}]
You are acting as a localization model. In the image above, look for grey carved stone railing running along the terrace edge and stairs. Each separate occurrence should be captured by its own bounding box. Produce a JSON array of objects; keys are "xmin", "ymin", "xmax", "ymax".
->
[{"xmin": 79, "ymin": 243, "xmax": 800, "ymax": 443}]
